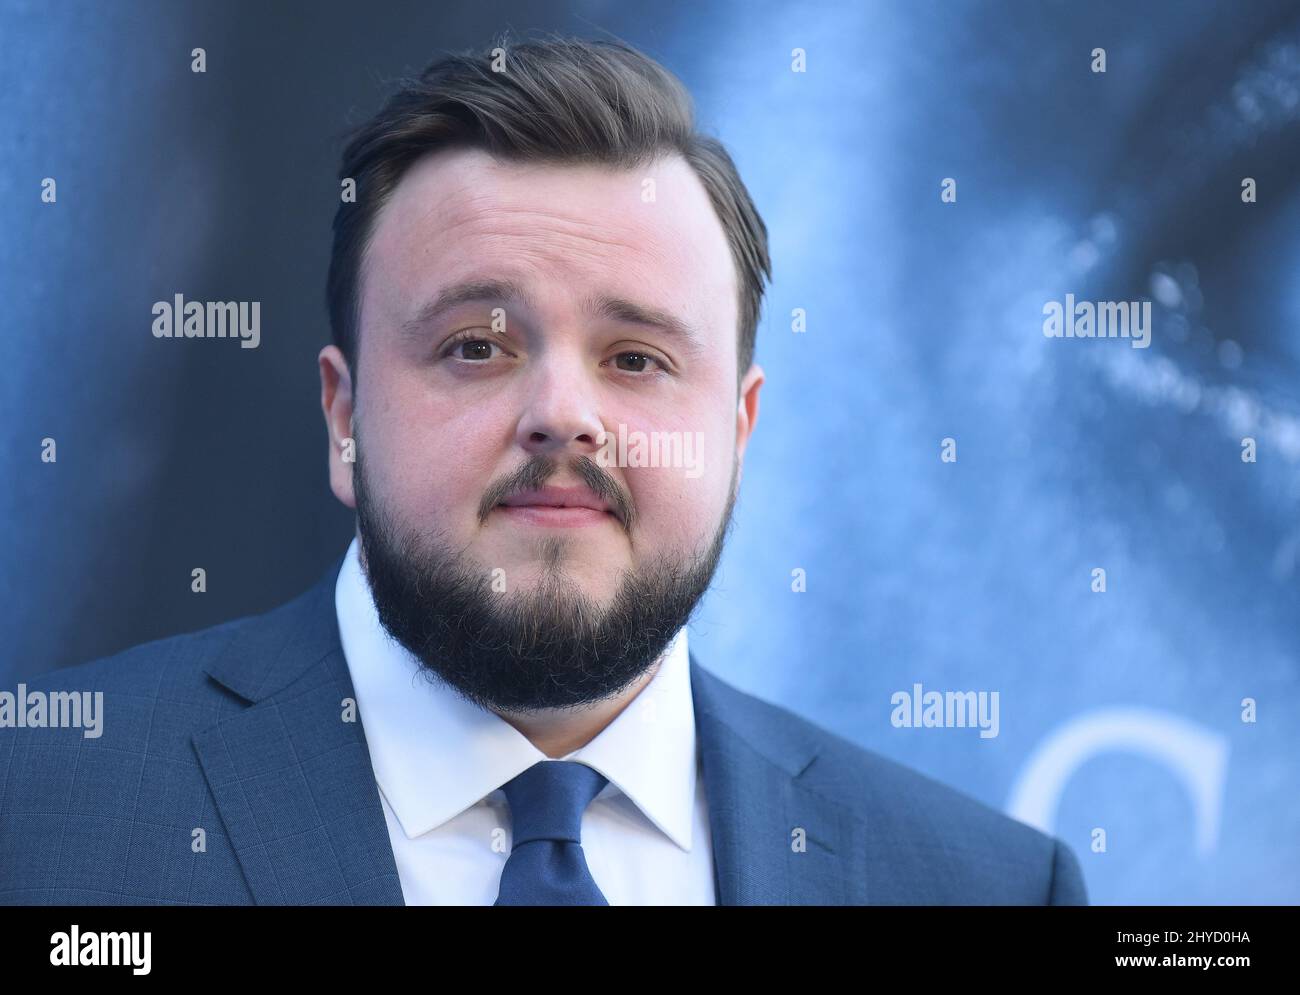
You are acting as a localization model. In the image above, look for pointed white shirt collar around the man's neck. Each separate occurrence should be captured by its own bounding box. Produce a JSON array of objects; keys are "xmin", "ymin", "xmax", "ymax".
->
[{"xmin": 334, "ymin": 537, "xmax": 697, "ymax": 851}]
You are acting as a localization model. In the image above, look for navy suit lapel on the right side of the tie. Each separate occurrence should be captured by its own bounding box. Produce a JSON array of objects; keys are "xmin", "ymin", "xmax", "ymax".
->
[{"xmin": 690, "ymin": 654, "xmax": 867, "ymax": 905}]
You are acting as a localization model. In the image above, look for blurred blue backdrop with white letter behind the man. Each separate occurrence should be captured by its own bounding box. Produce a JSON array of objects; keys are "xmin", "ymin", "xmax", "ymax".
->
[{"xmin": 0, "ymin": 0, "xmax": 1300, "ymax": 903}]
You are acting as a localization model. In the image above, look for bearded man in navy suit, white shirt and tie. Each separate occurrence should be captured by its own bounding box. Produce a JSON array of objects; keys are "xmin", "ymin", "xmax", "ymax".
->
[{"xmin": 0, "ymin": 34, "xmax": 1086, "ymax": 905}]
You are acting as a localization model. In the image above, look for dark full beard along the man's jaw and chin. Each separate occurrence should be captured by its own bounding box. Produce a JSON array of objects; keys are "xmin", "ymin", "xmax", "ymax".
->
[{"xmin": 352, "ymin": 427, "xmax": 737, "ymax": 714}]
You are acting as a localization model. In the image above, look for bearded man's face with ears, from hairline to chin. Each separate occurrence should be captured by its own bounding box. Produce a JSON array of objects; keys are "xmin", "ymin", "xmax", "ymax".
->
[{"xmin": 321, "ymin": 143, "xmax": 762, "ymax": 708}]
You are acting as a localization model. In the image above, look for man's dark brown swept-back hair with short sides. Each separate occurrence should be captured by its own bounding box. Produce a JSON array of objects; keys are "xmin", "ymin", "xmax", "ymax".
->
[{"xmin": 326, "ymin": 36, "xmax": 772, "ymax": 384}]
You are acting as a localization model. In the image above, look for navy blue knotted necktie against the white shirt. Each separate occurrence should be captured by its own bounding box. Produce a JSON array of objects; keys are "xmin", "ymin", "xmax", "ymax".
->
[{"xmin": 495, "ymin": 760, "xmax": 610, "ymax": 905}]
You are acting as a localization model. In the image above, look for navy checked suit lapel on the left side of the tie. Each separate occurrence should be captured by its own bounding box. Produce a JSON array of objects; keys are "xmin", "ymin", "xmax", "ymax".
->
[{"xmin": 194, "ymin": 559, "xmax": 403, "ymax": 905}]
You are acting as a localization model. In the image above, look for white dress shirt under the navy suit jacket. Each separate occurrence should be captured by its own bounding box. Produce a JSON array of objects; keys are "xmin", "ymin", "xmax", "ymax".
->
[{"xmin": 334, "ymin": 537, "xmax": 715, "ymax": 905}]
